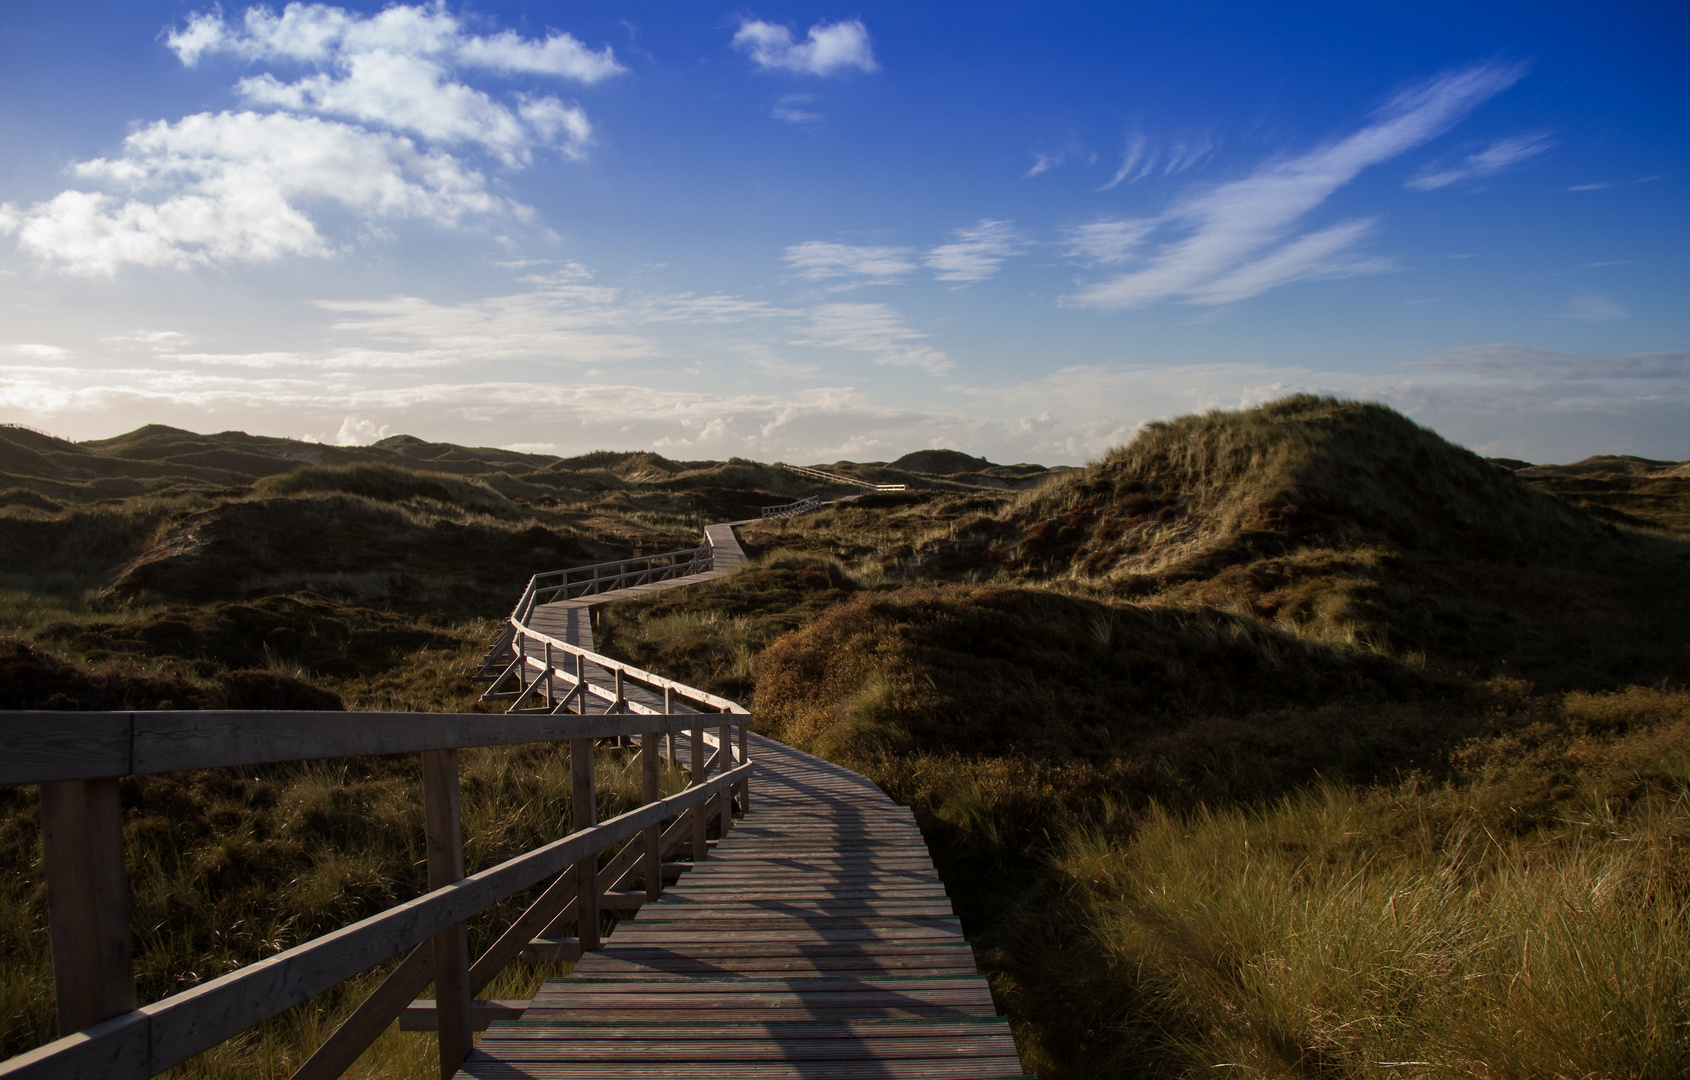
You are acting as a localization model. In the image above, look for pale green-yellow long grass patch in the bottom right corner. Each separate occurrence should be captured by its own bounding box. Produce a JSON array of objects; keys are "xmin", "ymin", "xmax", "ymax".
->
[{"xmin": 1000, "ymin": 693, "xmax": 1690, "ymax": 1080}]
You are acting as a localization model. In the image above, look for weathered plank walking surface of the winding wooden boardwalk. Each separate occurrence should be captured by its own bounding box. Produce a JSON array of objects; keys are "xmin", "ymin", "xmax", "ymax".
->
[{"xmin": 458, "ymin": 526, "xmax": 1024, "ymax": 1080}]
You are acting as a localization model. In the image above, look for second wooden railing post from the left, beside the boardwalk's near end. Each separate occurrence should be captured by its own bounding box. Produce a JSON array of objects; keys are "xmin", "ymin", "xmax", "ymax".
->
[{"xmin": 423, "ymin": 750, "xmax": 473, "ymax": 1080}]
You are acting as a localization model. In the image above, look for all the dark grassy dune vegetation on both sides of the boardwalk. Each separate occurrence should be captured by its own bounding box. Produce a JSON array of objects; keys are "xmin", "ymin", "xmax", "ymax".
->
[{"xmin": 0, "ymin": 407, "xmax": 1690, "ymax": 1080}]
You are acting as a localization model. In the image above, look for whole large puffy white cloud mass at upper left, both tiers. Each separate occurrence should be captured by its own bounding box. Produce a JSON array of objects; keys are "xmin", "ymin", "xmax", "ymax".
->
[{"xmin": 0, "ymin": 3, "xmax": 624, "ymax": 274}]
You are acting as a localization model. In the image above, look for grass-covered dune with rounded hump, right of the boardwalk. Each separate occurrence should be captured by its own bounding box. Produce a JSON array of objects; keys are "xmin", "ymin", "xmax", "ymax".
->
[{"xmin": 598, "ymin": 399, "xmax": 1690, "ymax": 1080}]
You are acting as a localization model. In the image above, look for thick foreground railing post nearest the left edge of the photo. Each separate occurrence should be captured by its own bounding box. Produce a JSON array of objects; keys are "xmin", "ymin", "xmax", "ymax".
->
[{"xmin": 41, "ymin": 779, "xmax": 135, "ymax": 1038}]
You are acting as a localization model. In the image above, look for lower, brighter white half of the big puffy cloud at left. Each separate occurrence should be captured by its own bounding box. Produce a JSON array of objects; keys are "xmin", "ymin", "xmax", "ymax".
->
[{"xmin": 14, "ymin": 112, "xmax": 507, "ymax": 274}]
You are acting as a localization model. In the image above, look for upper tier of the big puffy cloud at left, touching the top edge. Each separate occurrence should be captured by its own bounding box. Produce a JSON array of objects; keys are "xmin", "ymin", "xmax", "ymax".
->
[{"xmin": 167, "ymin": 3, "xmax": 625, "ymax": 166}]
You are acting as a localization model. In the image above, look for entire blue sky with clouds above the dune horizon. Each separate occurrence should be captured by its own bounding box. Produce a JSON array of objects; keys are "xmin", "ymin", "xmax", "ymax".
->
[{"xmin": 0, "ymin": 2, "xmax": 1690, "ymax": 463}]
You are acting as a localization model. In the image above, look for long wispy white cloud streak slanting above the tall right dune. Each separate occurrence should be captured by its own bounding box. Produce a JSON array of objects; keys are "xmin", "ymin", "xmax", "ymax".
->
[{"xmin": 1073, "ymin": 64, "xmax": 1524, "ymax": 308}]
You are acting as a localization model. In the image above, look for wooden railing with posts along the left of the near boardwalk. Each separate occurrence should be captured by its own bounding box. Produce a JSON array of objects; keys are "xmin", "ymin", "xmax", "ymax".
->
[{"xmin": 0, "ymin": 679, "xmax": 752, "ymax": 1080}]
